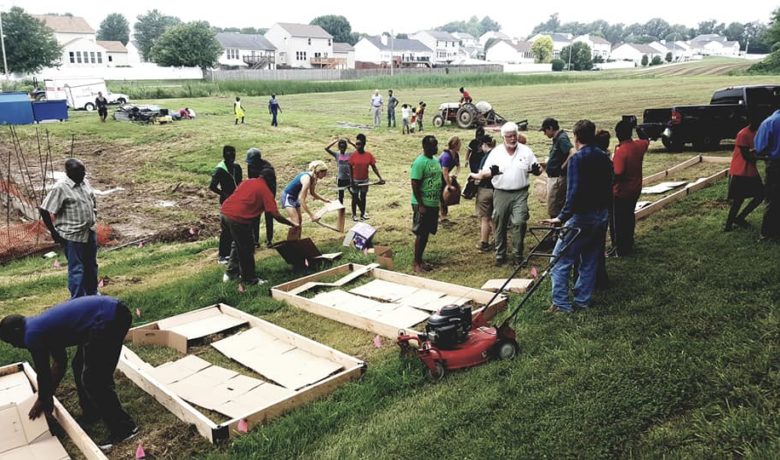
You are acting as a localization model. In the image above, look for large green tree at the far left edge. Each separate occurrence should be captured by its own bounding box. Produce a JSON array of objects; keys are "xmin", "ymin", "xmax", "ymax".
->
[{"xmin": 0, "ymin": 6, "xmax": 62, "ymax": 73}]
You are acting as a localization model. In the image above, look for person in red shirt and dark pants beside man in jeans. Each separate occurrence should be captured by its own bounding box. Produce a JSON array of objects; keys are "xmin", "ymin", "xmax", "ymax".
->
[{"xmin": 609, "ymin": 120, "xmax": 650, "ymax": 257}]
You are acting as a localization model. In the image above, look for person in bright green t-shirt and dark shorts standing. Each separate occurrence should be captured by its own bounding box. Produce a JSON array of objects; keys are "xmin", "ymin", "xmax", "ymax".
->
[{"xmin": 409, "ymin": 135, "xmax": 442, "ymax": 273}]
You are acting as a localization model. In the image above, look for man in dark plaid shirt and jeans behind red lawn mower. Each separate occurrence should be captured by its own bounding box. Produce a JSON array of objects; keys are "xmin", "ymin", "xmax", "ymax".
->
[{"xmin": 543, "ymin": 120, "xmax": 612, "ymax": 313}]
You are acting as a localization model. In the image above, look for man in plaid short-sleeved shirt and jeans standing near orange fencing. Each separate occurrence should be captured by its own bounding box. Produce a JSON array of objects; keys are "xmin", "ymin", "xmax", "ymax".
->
[{"xmin": 40, "ymin": 158, "xmax": 98, "ymax": 298}]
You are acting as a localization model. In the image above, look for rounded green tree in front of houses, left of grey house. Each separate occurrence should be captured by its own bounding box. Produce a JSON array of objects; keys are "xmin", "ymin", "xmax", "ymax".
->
[{"xmin": 152, "ymin": 21, "xmax": 222, "ymax": 70}]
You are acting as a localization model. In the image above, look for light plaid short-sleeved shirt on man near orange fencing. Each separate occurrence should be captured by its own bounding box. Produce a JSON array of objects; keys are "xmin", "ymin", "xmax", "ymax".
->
[{"xmin": 41, "ymin": 177, "xmax": 97, "ymax": 243}]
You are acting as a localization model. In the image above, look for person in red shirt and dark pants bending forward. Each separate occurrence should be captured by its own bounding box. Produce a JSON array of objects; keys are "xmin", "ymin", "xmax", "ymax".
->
[{"xmin": 220, "ymin": 164, "xmax": 298, "ymax": 286}]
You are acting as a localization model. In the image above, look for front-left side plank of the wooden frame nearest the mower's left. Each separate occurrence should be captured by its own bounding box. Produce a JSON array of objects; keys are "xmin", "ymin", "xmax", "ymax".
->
[{"xmin": 117, "ymin": 347, "xmax": 218, "ymax": 443}]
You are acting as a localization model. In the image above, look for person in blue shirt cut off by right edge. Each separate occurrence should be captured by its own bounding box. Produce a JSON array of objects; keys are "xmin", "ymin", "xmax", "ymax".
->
[{"xmin": 753, "ymin": 110, "xmax": 780, "ymax": 239}]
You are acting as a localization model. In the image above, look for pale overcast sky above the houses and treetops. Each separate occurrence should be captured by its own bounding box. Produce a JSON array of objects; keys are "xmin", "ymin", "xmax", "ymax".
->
[{"xmin": 6, "ymin": 0, "xmax": 778, "ymax": 37}]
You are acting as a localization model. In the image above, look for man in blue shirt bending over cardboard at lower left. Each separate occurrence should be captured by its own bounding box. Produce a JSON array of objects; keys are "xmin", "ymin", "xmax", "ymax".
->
[{"xmin": 0, "ymin": 296, "xmax": 138, "ymax": 450}]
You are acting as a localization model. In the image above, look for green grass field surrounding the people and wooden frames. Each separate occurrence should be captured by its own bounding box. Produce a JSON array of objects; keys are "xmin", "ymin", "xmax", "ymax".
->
[{"xmin": 0, "ymin": 66, "xmax": 780, "ymax": 458}]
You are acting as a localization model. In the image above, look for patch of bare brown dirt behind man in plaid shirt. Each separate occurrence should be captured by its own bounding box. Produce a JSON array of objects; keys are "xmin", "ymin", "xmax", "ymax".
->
[{"xmin": 0, "ymin": 135, "xmax": 219, "ymax": 245}]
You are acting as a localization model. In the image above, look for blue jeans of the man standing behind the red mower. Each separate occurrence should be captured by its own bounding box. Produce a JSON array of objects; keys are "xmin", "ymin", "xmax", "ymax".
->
[{"xmin": 550, "ymin": 209, "xmax": 609, "ymax": 312}]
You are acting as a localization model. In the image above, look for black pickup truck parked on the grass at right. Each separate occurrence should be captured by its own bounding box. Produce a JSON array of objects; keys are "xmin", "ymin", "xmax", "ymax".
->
[{"xmin": 639, "ymin": 85, "xmax": 780, "ymax": 152}]
